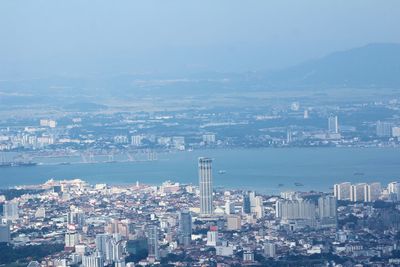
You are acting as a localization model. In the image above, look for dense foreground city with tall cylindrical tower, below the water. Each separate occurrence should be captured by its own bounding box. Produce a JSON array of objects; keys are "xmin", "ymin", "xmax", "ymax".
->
[{"xmin": 0, "ymin": 158, "xmax": 400, "ymax": 267}]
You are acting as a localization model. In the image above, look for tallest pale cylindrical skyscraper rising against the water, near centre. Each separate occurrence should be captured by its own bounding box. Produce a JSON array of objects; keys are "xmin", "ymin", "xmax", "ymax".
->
[{"xmin": 199, "ymin": 158, "xmax": 214, "ymax": 215}]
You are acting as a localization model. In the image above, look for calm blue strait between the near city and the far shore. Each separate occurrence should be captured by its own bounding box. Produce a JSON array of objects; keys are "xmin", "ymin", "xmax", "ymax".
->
[{"xmin": 0, "ymin": 148, "xmax": 400, "ymax": 193}]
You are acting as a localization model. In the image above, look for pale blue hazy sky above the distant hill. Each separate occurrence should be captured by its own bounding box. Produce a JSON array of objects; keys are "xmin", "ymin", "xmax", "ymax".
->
[{"xmin": 0, "ymin": 0, "xmax": 400, "ymax": 78}]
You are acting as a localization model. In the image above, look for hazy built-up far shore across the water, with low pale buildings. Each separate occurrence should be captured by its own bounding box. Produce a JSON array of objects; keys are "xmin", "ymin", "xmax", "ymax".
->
[{"xmin": 0, "ymin": 98, "xmax": 400, "ymax": 167}]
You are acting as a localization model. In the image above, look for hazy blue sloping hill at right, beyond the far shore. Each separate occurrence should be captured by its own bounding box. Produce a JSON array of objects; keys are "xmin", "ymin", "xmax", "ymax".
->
[{"xmin": 266, "ymin": 44, "xmax": 400, "ymax": 88}]
